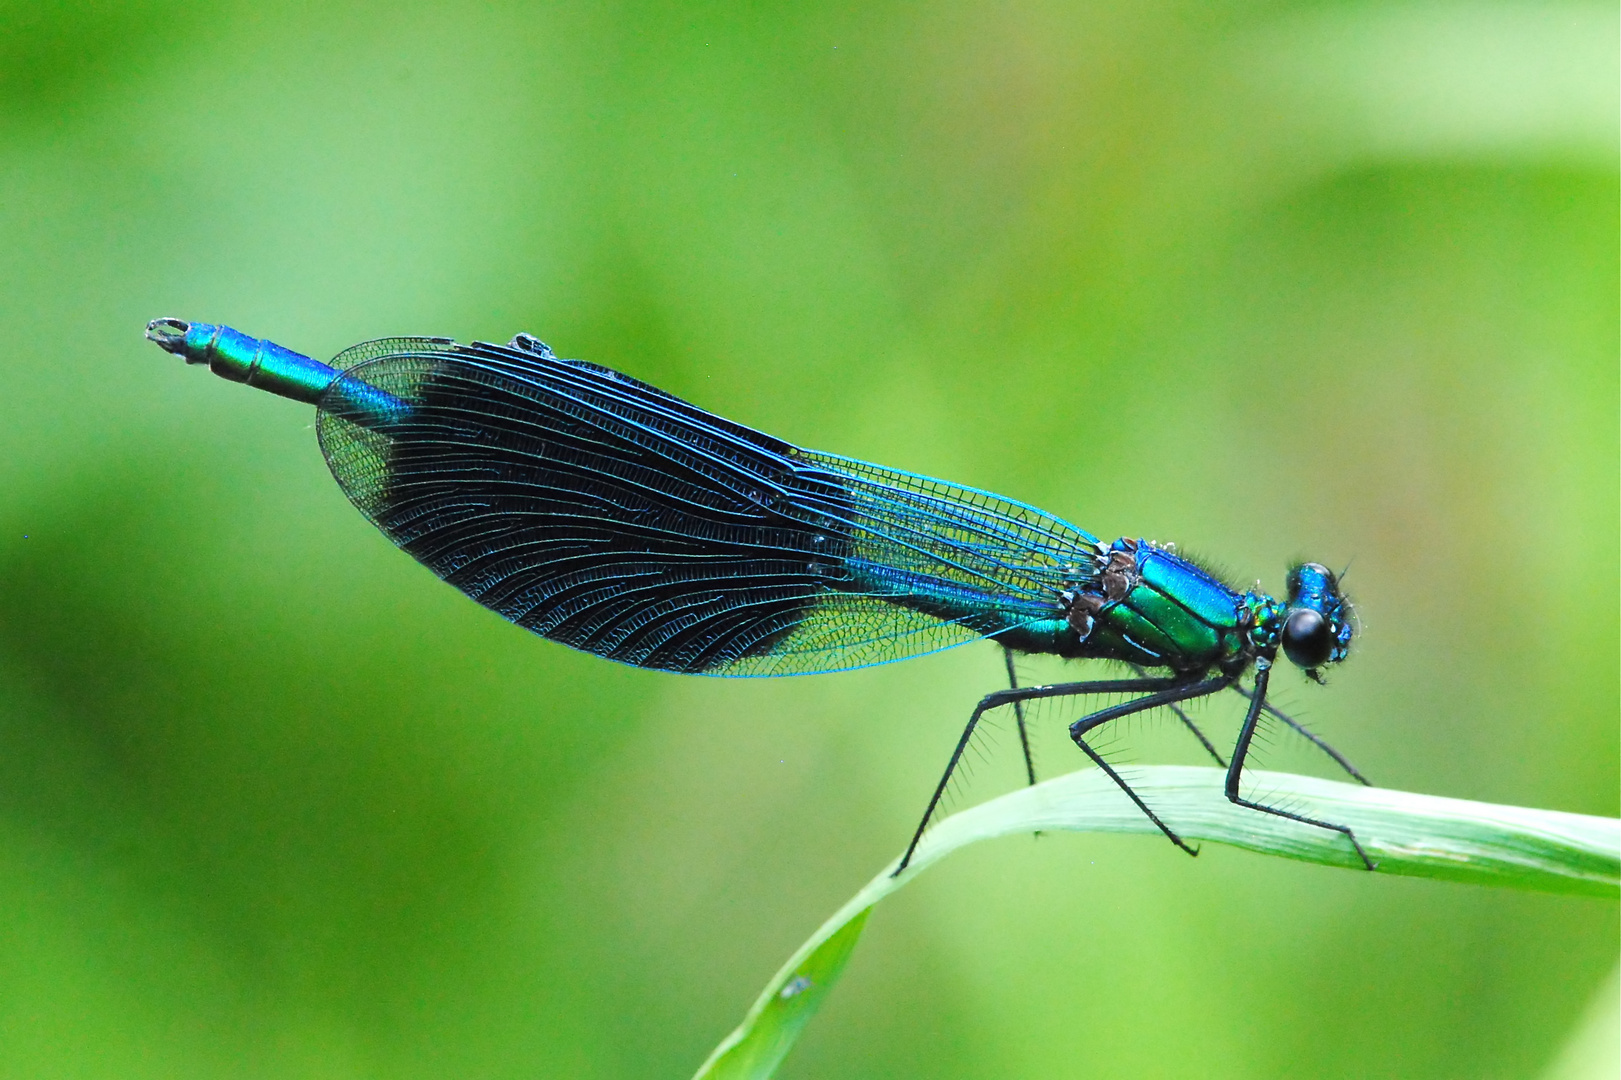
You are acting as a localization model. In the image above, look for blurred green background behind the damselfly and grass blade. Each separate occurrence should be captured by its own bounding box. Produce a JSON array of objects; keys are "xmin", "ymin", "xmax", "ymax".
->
[{"xmin": 0, "ymin": 0, "xmax": 1621, "ymax": 1078}]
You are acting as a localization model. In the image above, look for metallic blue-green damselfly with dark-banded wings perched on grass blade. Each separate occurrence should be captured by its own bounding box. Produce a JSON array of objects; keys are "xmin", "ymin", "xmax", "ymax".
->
[{"xmin": 146, "ymin": 318, "xmax": 1373, "ymax": 872}]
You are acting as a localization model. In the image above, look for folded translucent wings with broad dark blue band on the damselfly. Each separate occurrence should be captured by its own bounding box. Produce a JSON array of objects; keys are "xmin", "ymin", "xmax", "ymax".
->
[{"xmin": 318, "ymin": 339, "xmax": 1097, "ymax": 675}]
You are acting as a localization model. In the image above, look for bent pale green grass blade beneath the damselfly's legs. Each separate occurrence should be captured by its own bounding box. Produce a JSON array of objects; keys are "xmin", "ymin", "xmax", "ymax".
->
[{"xmin": 697, "ymin": 765, "xmax": 1621, "ymax": 1080}]
